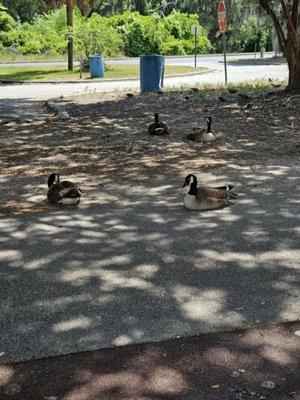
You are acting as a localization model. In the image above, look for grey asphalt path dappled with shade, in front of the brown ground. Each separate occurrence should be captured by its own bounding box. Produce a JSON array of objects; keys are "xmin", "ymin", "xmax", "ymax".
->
[{"xmin": 0, "ymin": 158, "xmax": 300, "ymax": 363}]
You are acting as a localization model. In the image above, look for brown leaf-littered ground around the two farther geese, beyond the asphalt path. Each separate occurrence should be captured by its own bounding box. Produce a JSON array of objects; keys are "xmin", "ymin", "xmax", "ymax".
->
[{"xmin": 0, "ymin": 87, "xmax": 300, "ymax": 212}]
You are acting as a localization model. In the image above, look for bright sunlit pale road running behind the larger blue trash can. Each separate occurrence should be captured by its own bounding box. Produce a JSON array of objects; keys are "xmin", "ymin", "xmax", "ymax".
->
[{"xmin": 0, "ymin": 54, "xmax": 288, "ymax": 123}]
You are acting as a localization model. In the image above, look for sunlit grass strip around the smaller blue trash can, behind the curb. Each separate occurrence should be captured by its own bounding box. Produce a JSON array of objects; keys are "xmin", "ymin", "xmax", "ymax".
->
[{"xmin": 0, "ymin": 65, "xmax": 208, "ymax": 81}]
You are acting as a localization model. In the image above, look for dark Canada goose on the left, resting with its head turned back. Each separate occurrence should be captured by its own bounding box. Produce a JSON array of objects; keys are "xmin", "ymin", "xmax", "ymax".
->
[{"xmin": 47, "ymin": 174, "xmax": 81, "ymax": 205}]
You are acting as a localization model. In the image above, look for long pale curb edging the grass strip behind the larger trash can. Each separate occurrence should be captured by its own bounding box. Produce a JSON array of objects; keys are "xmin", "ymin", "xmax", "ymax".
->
[{"xmin": 0, "ymin": 68, "xmax": 214, "ymax": 85}]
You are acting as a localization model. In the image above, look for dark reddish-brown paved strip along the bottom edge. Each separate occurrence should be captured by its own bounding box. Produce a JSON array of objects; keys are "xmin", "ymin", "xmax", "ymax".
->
[{"xmin": 0, "ymin": 323, "xmax": 300, "ymax": 400}]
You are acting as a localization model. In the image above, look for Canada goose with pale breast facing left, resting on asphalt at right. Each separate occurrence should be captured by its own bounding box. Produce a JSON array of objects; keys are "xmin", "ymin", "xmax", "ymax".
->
[{"xmin": 182, "ymin": 174, "xmax": 237, "ymax": 210}]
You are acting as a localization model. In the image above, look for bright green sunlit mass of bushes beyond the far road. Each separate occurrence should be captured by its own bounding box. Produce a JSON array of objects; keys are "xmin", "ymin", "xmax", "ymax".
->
[{"xmin": 0, "ymin": 6, "xmax": 211, "ymax": 57}]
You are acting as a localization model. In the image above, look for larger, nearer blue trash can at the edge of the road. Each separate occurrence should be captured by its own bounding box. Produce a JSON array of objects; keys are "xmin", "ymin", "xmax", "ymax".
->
[{"xmin": 140, "ymin": 54, "xmax": 165, "ymax": 92}]
